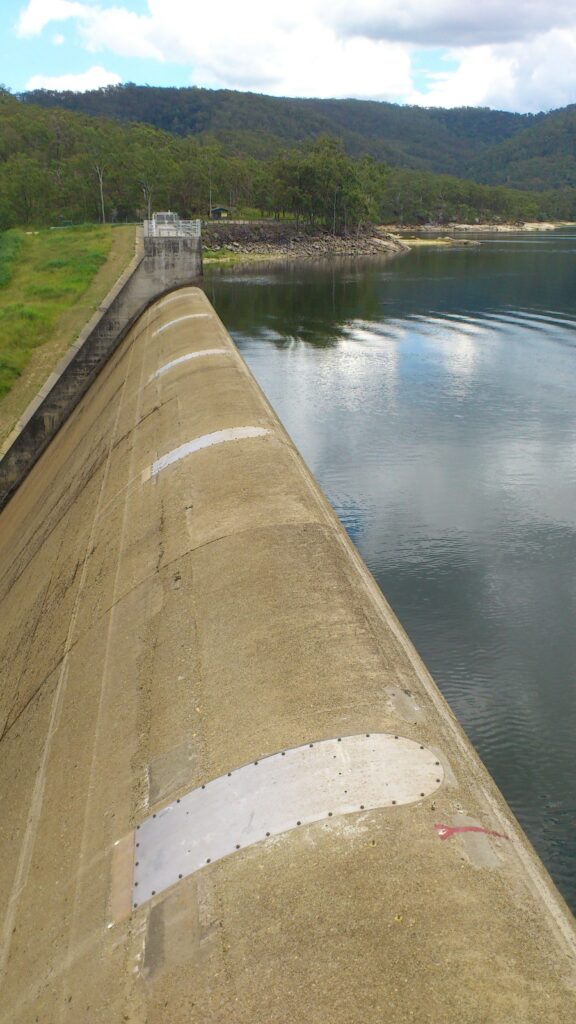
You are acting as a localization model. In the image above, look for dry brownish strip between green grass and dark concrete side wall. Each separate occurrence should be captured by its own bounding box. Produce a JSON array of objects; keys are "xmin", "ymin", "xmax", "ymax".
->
[{"xmin": 0, "ymin": 225, "xmax": 135, "ymax": 448}]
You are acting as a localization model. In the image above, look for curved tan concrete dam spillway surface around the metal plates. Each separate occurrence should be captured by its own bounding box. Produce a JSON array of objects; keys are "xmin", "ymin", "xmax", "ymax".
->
[{"xmin": 0, "ymin": 288, "xmax": 576, "ymax": 1024}]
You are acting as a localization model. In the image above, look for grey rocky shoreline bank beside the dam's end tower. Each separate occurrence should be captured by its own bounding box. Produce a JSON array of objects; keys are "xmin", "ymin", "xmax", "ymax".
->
[{"xmin": 202, "ymin": 221, "xmax": 410, "ymax": 263}]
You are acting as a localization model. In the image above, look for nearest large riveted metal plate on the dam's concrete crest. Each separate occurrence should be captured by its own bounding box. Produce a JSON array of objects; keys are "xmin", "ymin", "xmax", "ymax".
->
[{"xmin": 133, "ymin": 733, "xmax": 444, "ymax": 907}]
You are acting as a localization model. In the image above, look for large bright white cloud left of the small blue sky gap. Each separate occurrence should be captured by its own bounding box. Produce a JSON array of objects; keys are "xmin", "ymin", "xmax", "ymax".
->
[{"xmin": 18, "ymin": 0, "xmax": 411, "ymax": 99}]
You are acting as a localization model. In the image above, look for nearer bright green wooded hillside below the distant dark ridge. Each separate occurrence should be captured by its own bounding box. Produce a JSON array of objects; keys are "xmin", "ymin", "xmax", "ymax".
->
[{"xmin": 0, "ymin": 89, "xmax": 576, "ymax": 232}]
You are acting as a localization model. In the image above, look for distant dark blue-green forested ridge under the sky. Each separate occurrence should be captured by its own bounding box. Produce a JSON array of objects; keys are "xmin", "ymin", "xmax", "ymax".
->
[{"xmin": 20, "ymin": 84, "xmax": 576, "ymax": 190}]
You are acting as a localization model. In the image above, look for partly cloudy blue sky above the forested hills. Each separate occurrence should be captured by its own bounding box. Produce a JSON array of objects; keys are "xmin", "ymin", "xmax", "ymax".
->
[{"xmin": 0, "ymin": 0, "xmax": 576, "ymax": 113}]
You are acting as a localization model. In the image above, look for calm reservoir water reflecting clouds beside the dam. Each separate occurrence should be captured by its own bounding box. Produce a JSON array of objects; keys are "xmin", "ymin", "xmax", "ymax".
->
[{"xmin": 205, "ymin": 230, "xmax": 576, "ymax": 908}]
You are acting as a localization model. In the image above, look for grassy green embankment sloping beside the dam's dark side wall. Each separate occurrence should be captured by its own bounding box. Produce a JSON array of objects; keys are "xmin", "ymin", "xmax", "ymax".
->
[{"xmin": 0, "ymin": 225, "xmax": 134, "ymax": 452}]
